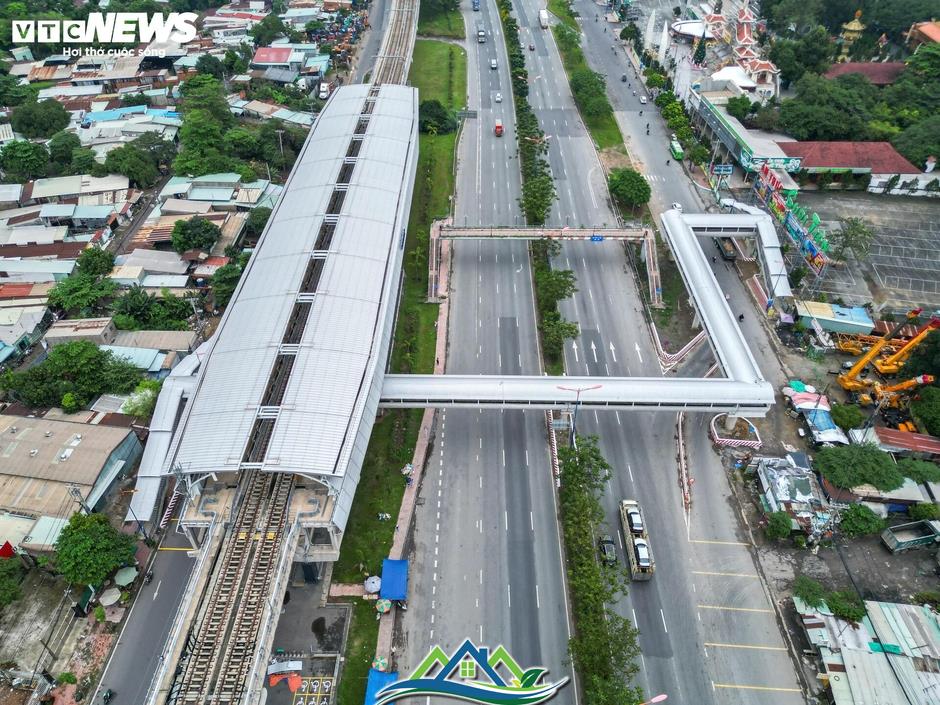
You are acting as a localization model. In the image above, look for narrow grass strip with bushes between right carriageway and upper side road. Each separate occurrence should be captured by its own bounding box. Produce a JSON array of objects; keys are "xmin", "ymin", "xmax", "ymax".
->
[{"xmin": 552, "ymin": 21, "xmax": 623, "ymax": 149}]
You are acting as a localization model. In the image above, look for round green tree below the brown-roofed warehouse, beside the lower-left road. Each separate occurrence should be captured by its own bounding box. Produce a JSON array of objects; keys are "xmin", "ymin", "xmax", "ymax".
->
[{"xmin": 55, "ymin": 512, "xmax": 137, "ymax": 585}]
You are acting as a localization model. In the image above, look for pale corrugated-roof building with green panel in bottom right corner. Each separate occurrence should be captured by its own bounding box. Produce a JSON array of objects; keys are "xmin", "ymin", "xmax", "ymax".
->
[{"xmin": 793, "ymin": 597, "xmax": 940, "ymax": 705}]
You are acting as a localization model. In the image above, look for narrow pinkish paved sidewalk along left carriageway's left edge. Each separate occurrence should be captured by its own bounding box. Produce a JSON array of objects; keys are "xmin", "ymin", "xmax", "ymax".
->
[{"xmin": 372, "ymin": 221, "xmax": 451, "ymax": 667}]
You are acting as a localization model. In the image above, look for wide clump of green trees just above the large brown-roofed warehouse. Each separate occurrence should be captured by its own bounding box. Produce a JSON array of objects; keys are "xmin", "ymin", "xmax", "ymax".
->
[{"xmin": 0, "ymin": 340, "xmax": 140, "ymax": 407}]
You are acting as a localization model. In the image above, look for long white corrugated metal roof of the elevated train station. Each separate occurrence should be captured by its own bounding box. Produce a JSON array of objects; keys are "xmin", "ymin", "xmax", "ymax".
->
[{"xmin": 175, "ymin": 86, "xmax": 416, "ymax": 478}]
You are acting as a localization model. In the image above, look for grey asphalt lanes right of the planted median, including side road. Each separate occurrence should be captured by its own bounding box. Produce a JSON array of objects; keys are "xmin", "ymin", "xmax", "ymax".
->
[{"xmin": 500, "ymin": 0, "xmax": 802, "ymax": 704}]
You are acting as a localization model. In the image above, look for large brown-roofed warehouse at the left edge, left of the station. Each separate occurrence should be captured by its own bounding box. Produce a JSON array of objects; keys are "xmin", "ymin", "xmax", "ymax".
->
[{"xmin": 0, "ymin": 414, "xmax": 143, "ymax": 551}]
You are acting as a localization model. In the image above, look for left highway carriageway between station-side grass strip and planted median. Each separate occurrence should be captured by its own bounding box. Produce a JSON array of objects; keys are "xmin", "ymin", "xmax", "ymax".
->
[{"xmin": 398, "ymin": 2, "xmax": 575, "ymax": 703}]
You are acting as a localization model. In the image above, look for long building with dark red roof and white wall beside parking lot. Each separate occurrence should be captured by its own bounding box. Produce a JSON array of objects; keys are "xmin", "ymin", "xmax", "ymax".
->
[{"xmin": 777, "ymin": 142, "xmax": 940, "ymax": 197}]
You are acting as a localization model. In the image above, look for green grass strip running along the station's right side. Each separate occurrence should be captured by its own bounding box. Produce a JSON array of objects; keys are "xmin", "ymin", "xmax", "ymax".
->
[{"xmin": 333, "ymin": 40, "xmax": 467, "ymax": 583}]
